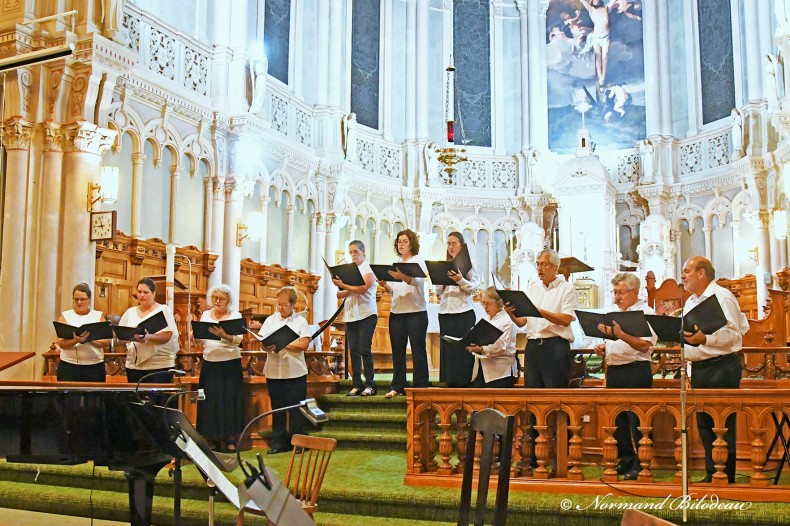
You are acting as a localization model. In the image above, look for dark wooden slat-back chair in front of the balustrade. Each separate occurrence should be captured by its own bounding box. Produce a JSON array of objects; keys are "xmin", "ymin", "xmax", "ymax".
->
[{"xmin": 458, "ymin": 409, "xmax": 516, "ymax": 526}]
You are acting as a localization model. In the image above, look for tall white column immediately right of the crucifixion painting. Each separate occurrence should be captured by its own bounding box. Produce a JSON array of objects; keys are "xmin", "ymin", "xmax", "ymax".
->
[{"xmin": 642, "ymin": 0, "xmax": 663, "ymax": 136}]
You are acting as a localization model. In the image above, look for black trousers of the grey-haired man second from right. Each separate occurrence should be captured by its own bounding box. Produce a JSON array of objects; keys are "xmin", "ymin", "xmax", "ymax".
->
[{"xmin": 606, "ymin": 361, "xmax": 653, "ymax": 471}]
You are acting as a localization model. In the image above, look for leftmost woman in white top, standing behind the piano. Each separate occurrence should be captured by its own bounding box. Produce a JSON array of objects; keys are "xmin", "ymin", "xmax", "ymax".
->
[{"xmin": 55, "ymin": 283, "xmax": 110, "ymax": 382}]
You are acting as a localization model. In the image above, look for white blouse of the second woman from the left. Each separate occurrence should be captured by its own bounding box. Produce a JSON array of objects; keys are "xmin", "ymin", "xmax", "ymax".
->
[{"xmin": 118, "ymin": 303, "xmax": 178, "ymax": 370}]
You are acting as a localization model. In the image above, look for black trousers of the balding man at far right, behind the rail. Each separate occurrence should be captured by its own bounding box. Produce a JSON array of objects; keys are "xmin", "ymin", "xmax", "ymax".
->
[{"xmin": 691, "ymin": 353, "xmax": 743, "ymax": 483}]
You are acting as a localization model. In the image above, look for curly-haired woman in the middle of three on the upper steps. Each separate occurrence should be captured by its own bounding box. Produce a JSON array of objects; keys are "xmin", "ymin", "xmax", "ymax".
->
[{"xmin": 379, "ymin": 229, "xmax": 428, "ymax": 398}]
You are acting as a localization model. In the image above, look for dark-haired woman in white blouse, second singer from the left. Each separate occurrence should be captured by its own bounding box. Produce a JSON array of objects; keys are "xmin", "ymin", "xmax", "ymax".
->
[{"xmin": 118, "ymin": 278, "xmax": 178, "ymax": 383}]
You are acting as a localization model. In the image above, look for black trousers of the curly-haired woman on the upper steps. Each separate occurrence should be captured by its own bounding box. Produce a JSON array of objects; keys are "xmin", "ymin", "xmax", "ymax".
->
[{"xmin": 390, "ymin": 311, "xmax": 428, "ymax": 393}]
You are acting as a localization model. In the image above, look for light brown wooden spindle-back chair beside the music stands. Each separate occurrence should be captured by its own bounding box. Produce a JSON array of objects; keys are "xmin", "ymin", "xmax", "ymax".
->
[{"xmin": 236, "ymin": 435, "xmax": 337, "ymax": 526}]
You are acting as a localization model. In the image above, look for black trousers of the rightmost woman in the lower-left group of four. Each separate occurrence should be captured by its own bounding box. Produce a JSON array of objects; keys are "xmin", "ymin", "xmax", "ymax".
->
[{"xmin": 266, "ymin": 375, "xmax": 307, "ymax": 449}]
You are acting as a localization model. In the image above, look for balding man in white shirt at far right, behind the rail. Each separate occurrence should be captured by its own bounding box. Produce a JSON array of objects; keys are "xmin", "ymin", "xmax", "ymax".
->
[{"xmin": 680, "ymin": 256, "xmax": 743, "ymax": 483}]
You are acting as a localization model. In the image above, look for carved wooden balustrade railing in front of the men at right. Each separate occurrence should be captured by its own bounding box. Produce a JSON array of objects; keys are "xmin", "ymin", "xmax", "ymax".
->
[{"xmin": 405, "ymin": 388, "xmax": 790, "ymax": 502}]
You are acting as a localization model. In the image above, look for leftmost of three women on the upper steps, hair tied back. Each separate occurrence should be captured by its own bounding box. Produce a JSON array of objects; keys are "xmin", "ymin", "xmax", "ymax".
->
[{"xmin": 332, "ymin": 240, "xmax": 378, "ymax": 396}]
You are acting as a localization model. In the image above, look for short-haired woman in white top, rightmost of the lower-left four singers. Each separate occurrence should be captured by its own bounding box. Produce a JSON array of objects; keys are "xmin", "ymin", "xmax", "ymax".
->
[{"xmin": 258, "ymin": 287, "xmax": 310, "ymax": 455}]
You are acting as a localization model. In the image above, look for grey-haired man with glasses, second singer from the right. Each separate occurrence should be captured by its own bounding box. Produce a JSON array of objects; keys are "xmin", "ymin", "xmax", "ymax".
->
[{"xmin": 595, "ymin": 272, "xmax": 658, "ymax": 480}]
